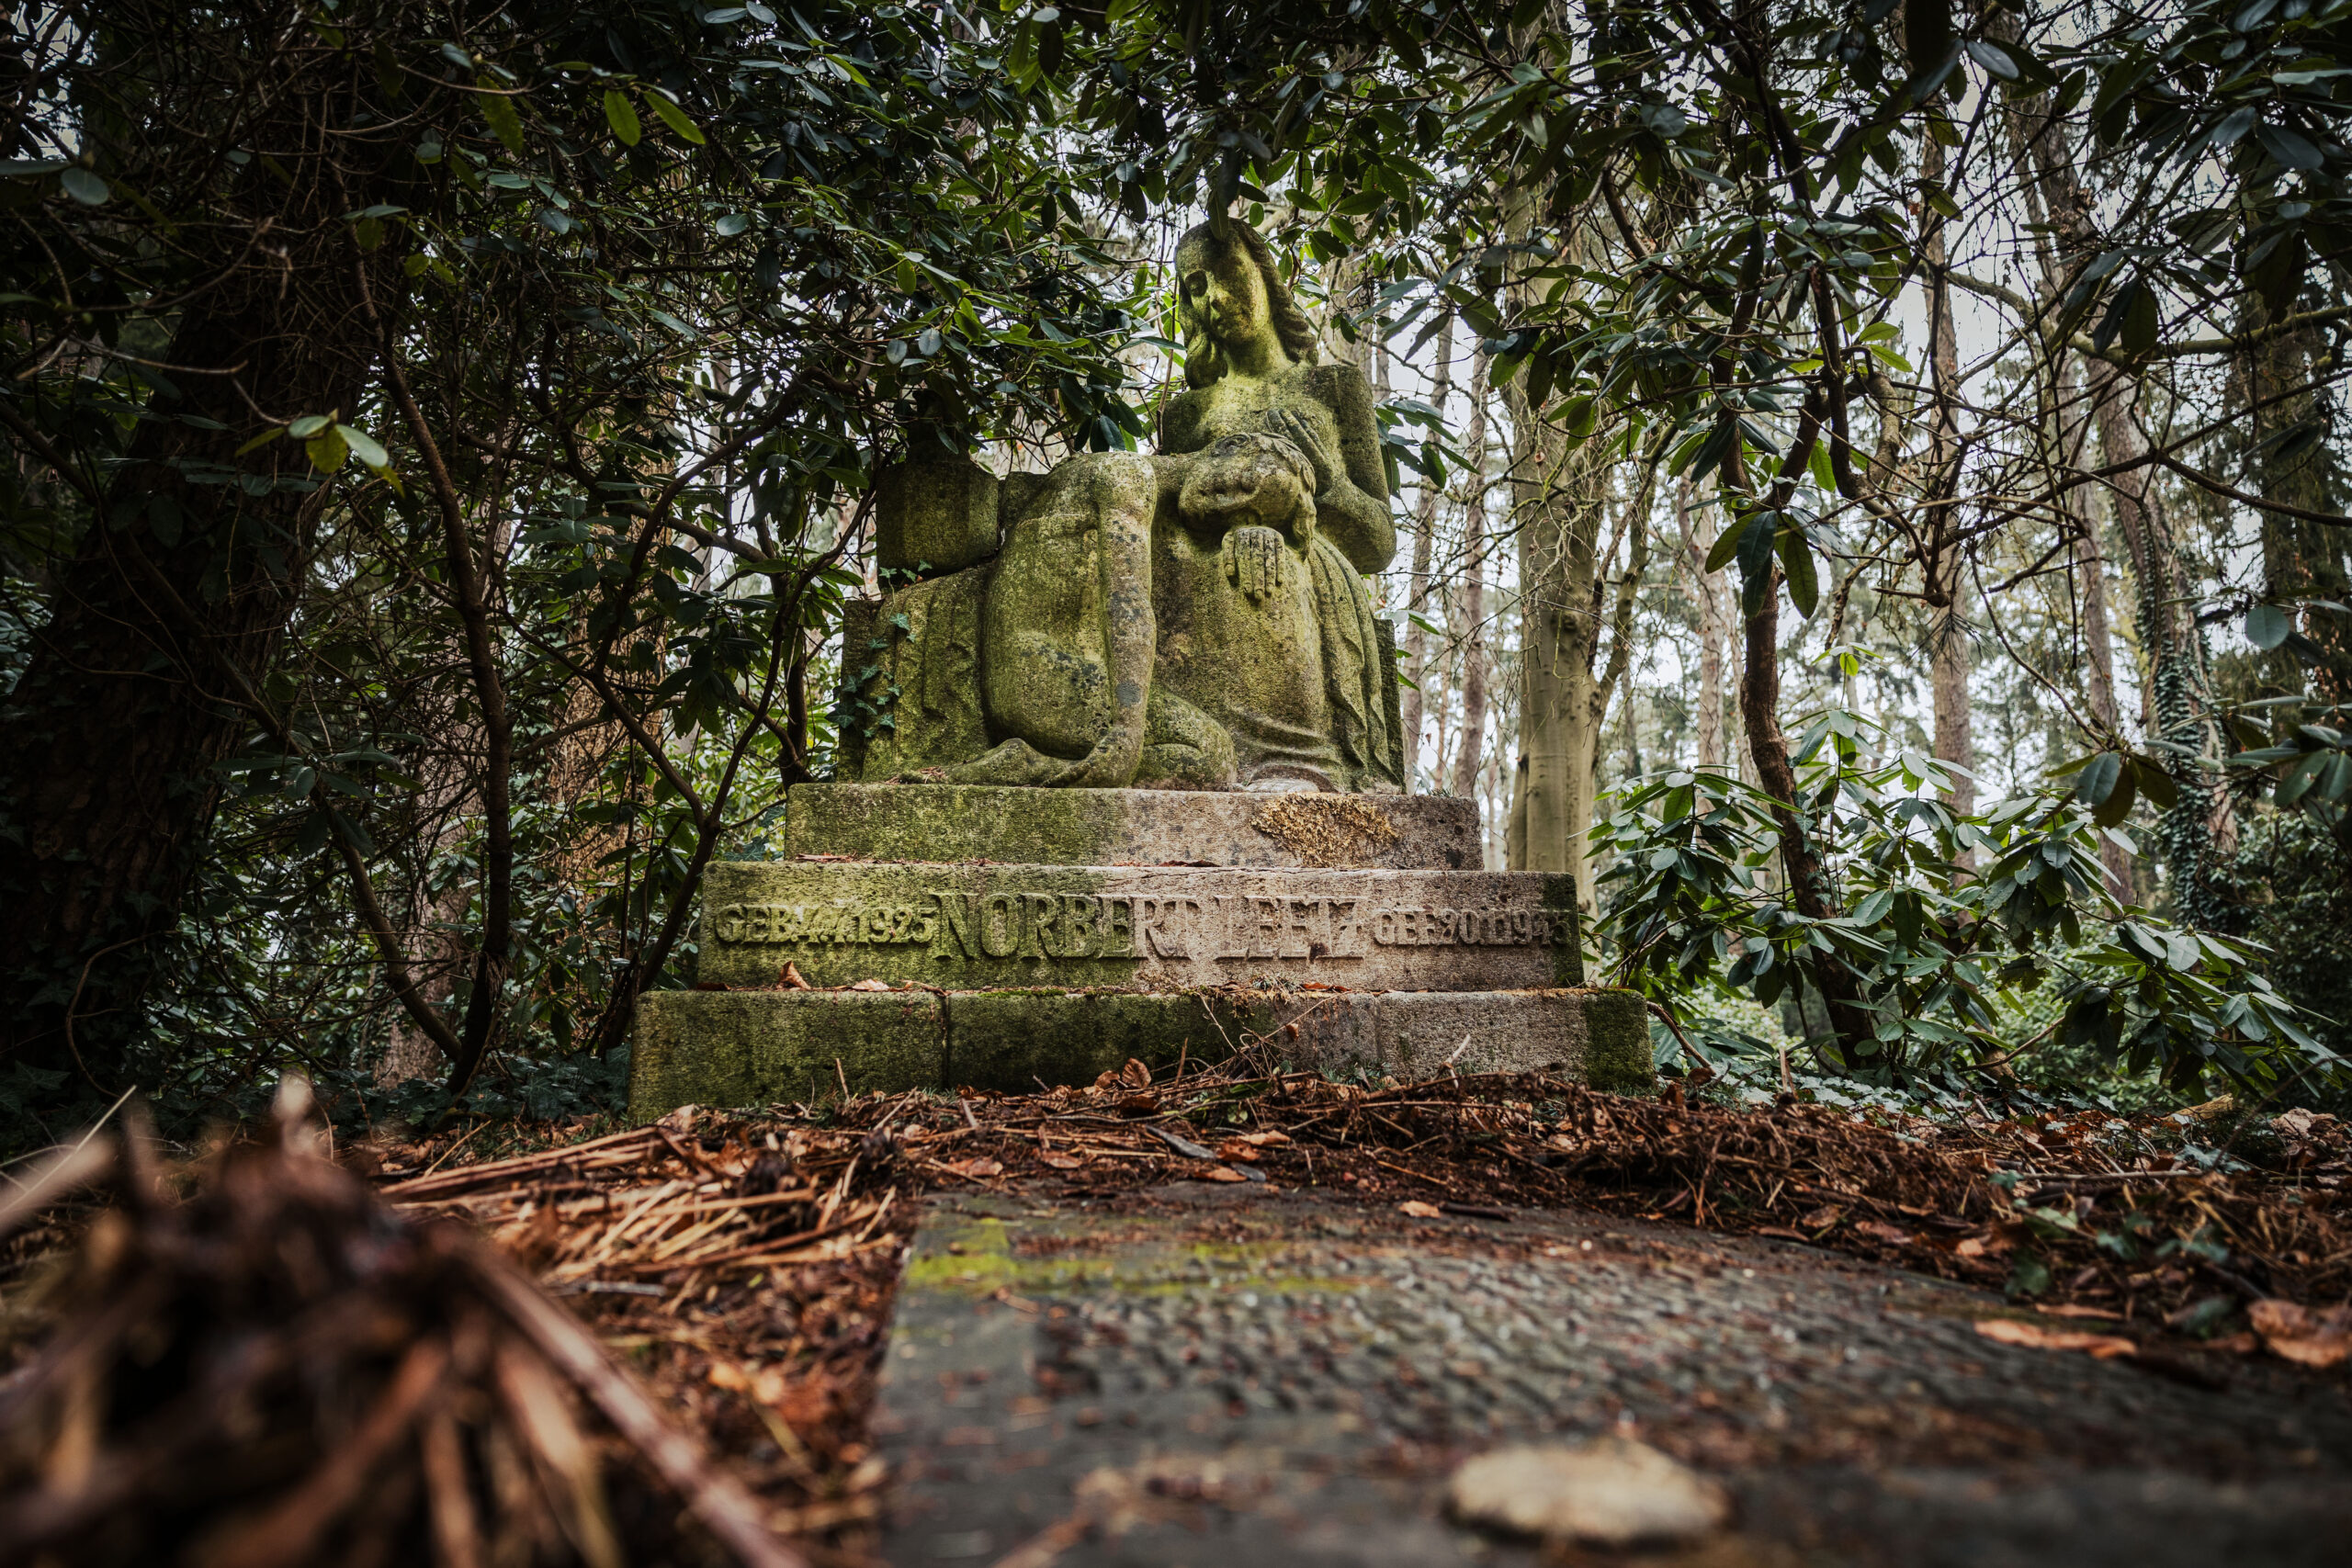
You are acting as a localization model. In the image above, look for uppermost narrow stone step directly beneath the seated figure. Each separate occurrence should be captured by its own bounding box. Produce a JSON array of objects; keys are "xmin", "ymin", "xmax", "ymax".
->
[{"xmin": 786, "ymin": 783, "xmax": 1482, "ymax": 872}]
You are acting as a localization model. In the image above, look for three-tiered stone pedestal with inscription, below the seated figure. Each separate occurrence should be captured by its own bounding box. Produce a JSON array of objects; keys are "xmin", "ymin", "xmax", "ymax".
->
[{"xmin": 630, "ymin": 785, "xmax": 1651, "ymax": 1119}]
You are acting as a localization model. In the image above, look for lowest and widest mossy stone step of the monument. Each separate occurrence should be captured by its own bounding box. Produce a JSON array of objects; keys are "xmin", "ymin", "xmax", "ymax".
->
[{"xmin": 628, "ymin": 989, "xmax": 1654, "ymax": 1122}]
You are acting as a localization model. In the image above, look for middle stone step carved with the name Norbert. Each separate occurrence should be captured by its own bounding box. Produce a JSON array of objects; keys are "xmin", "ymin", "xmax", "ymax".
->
[{"xmin": 698, "ymin": 861, "xmax": 1583, "ymax": 989}]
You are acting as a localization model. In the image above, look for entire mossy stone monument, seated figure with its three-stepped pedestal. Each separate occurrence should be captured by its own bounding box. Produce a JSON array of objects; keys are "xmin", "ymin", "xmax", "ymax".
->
[{"xmin": 628, "ymin": 223, "xmax": 1651, "ymax": 1119}]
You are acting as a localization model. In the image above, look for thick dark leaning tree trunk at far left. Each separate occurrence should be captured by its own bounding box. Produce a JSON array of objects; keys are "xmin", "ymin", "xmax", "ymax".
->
[{"xmin": 0, "ymin": 50, "xmax": 407, "ymax": 1093}]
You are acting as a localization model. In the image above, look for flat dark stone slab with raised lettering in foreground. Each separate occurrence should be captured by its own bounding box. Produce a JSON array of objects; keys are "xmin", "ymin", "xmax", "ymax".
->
[{"xmin": 873, "ymin": 1189, "xmax": 2352, "ymax": 1568}]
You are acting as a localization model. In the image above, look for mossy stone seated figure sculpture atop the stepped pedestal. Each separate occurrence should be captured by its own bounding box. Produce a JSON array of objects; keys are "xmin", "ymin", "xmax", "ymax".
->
[{"xmin": 844, "ymin": 223, "xmax": 1399, "ymax": 792}]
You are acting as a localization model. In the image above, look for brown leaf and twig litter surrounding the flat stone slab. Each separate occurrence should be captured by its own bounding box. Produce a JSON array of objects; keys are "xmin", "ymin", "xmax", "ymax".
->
[{"xmin": 0, "ymin": 1063, "xmax": 2352, "ymax": 1568}]
